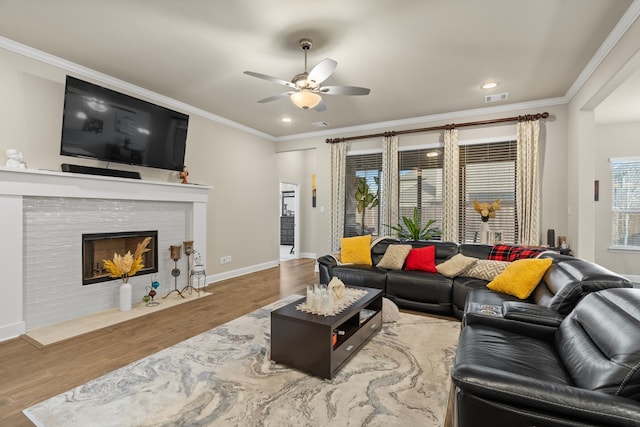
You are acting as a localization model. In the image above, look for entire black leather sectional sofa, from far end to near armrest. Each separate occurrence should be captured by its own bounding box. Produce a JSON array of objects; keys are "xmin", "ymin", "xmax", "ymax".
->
[{"xmin": 318, "ymin": 239, "xmax": 640, "ymax": 427}]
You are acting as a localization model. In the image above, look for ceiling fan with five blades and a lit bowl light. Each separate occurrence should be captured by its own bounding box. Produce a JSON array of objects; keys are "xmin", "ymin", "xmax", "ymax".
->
[{"xmin": 244, "ymin": 39, "xmax": 371, "ymax": 111}]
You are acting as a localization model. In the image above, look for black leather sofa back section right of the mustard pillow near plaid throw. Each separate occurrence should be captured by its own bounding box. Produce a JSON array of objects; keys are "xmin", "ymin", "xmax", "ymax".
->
[{"xmin": 533, "ymin": 252, "xmax": 632, "ymax": 315}]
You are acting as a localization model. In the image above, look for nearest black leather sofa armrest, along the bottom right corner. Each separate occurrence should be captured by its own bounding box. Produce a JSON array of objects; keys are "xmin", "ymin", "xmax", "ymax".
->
[{"xmin": 451, "ymin": 363, "xmax": 640, "ymax": 426}]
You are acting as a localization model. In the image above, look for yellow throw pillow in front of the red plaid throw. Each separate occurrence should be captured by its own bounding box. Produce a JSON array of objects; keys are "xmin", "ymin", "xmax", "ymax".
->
[{"xmin": 487, "ymin": 258, "xmax": 551, "ymax": 299}]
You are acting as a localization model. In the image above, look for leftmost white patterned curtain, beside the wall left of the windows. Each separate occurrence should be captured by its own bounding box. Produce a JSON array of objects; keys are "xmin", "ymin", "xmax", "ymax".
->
[{"xmin": 329, "ymin": 142, "xmax": 347, "ymax": 252}]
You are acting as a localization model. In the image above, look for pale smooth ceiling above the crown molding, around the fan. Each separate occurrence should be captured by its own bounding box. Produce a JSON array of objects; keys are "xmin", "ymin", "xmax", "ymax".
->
[{"xmin": 0, "ymin": 0, "xmax": 632, "ymax": 137}]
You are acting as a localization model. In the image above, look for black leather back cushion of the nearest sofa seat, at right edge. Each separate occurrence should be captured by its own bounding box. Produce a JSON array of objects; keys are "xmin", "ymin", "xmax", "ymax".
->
[{"xmin": 555, "ymin": 288, "xmax": 640, "ymax": 401}]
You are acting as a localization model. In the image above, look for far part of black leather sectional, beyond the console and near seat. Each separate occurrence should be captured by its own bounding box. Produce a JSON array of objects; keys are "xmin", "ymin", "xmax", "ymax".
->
[{"xmin": 318, "ymin": 239, "xmax": 632, "ymax": 319}]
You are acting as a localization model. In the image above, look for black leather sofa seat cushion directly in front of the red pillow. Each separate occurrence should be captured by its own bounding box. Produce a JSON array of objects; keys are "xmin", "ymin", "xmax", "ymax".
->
[{"xmin": 387, "ymin": 270, "xmax": 452, "ymax": 304}]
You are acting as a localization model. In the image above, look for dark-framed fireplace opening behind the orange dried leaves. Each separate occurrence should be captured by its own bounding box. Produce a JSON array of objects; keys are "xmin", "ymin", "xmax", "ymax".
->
[{"xmin": 82, "ymin": 230, "xmax": 158, "ymax": 285}]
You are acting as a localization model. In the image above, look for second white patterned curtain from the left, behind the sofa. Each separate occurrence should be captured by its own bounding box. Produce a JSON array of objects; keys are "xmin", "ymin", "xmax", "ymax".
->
[{"xmin": 378, "ymin": 135, "xmax": 399, "ymax": 236}]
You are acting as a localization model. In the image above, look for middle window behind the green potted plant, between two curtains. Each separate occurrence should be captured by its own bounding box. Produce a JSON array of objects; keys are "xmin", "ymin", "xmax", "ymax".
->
[{"xmin": 398, "ymin": 148, "xmax": 444, "ymax": 238}]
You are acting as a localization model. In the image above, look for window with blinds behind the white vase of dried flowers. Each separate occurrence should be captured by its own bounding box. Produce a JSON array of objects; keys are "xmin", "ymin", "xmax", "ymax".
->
[{"xmin": 459, "ymin": 141, "xmax": 518, "ymax": 243}]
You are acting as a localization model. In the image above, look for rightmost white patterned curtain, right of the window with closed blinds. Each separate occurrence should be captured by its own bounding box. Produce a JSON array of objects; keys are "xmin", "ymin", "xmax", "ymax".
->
[{"xmin": 516, "ymin": 120, "xmax": 540, "ymax": 246}]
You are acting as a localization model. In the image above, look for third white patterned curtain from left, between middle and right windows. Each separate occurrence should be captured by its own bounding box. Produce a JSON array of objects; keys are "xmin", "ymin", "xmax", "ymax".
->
[{"xmin": 441, "ymin": 129, "xmax": 460, "ymax": 242}]
